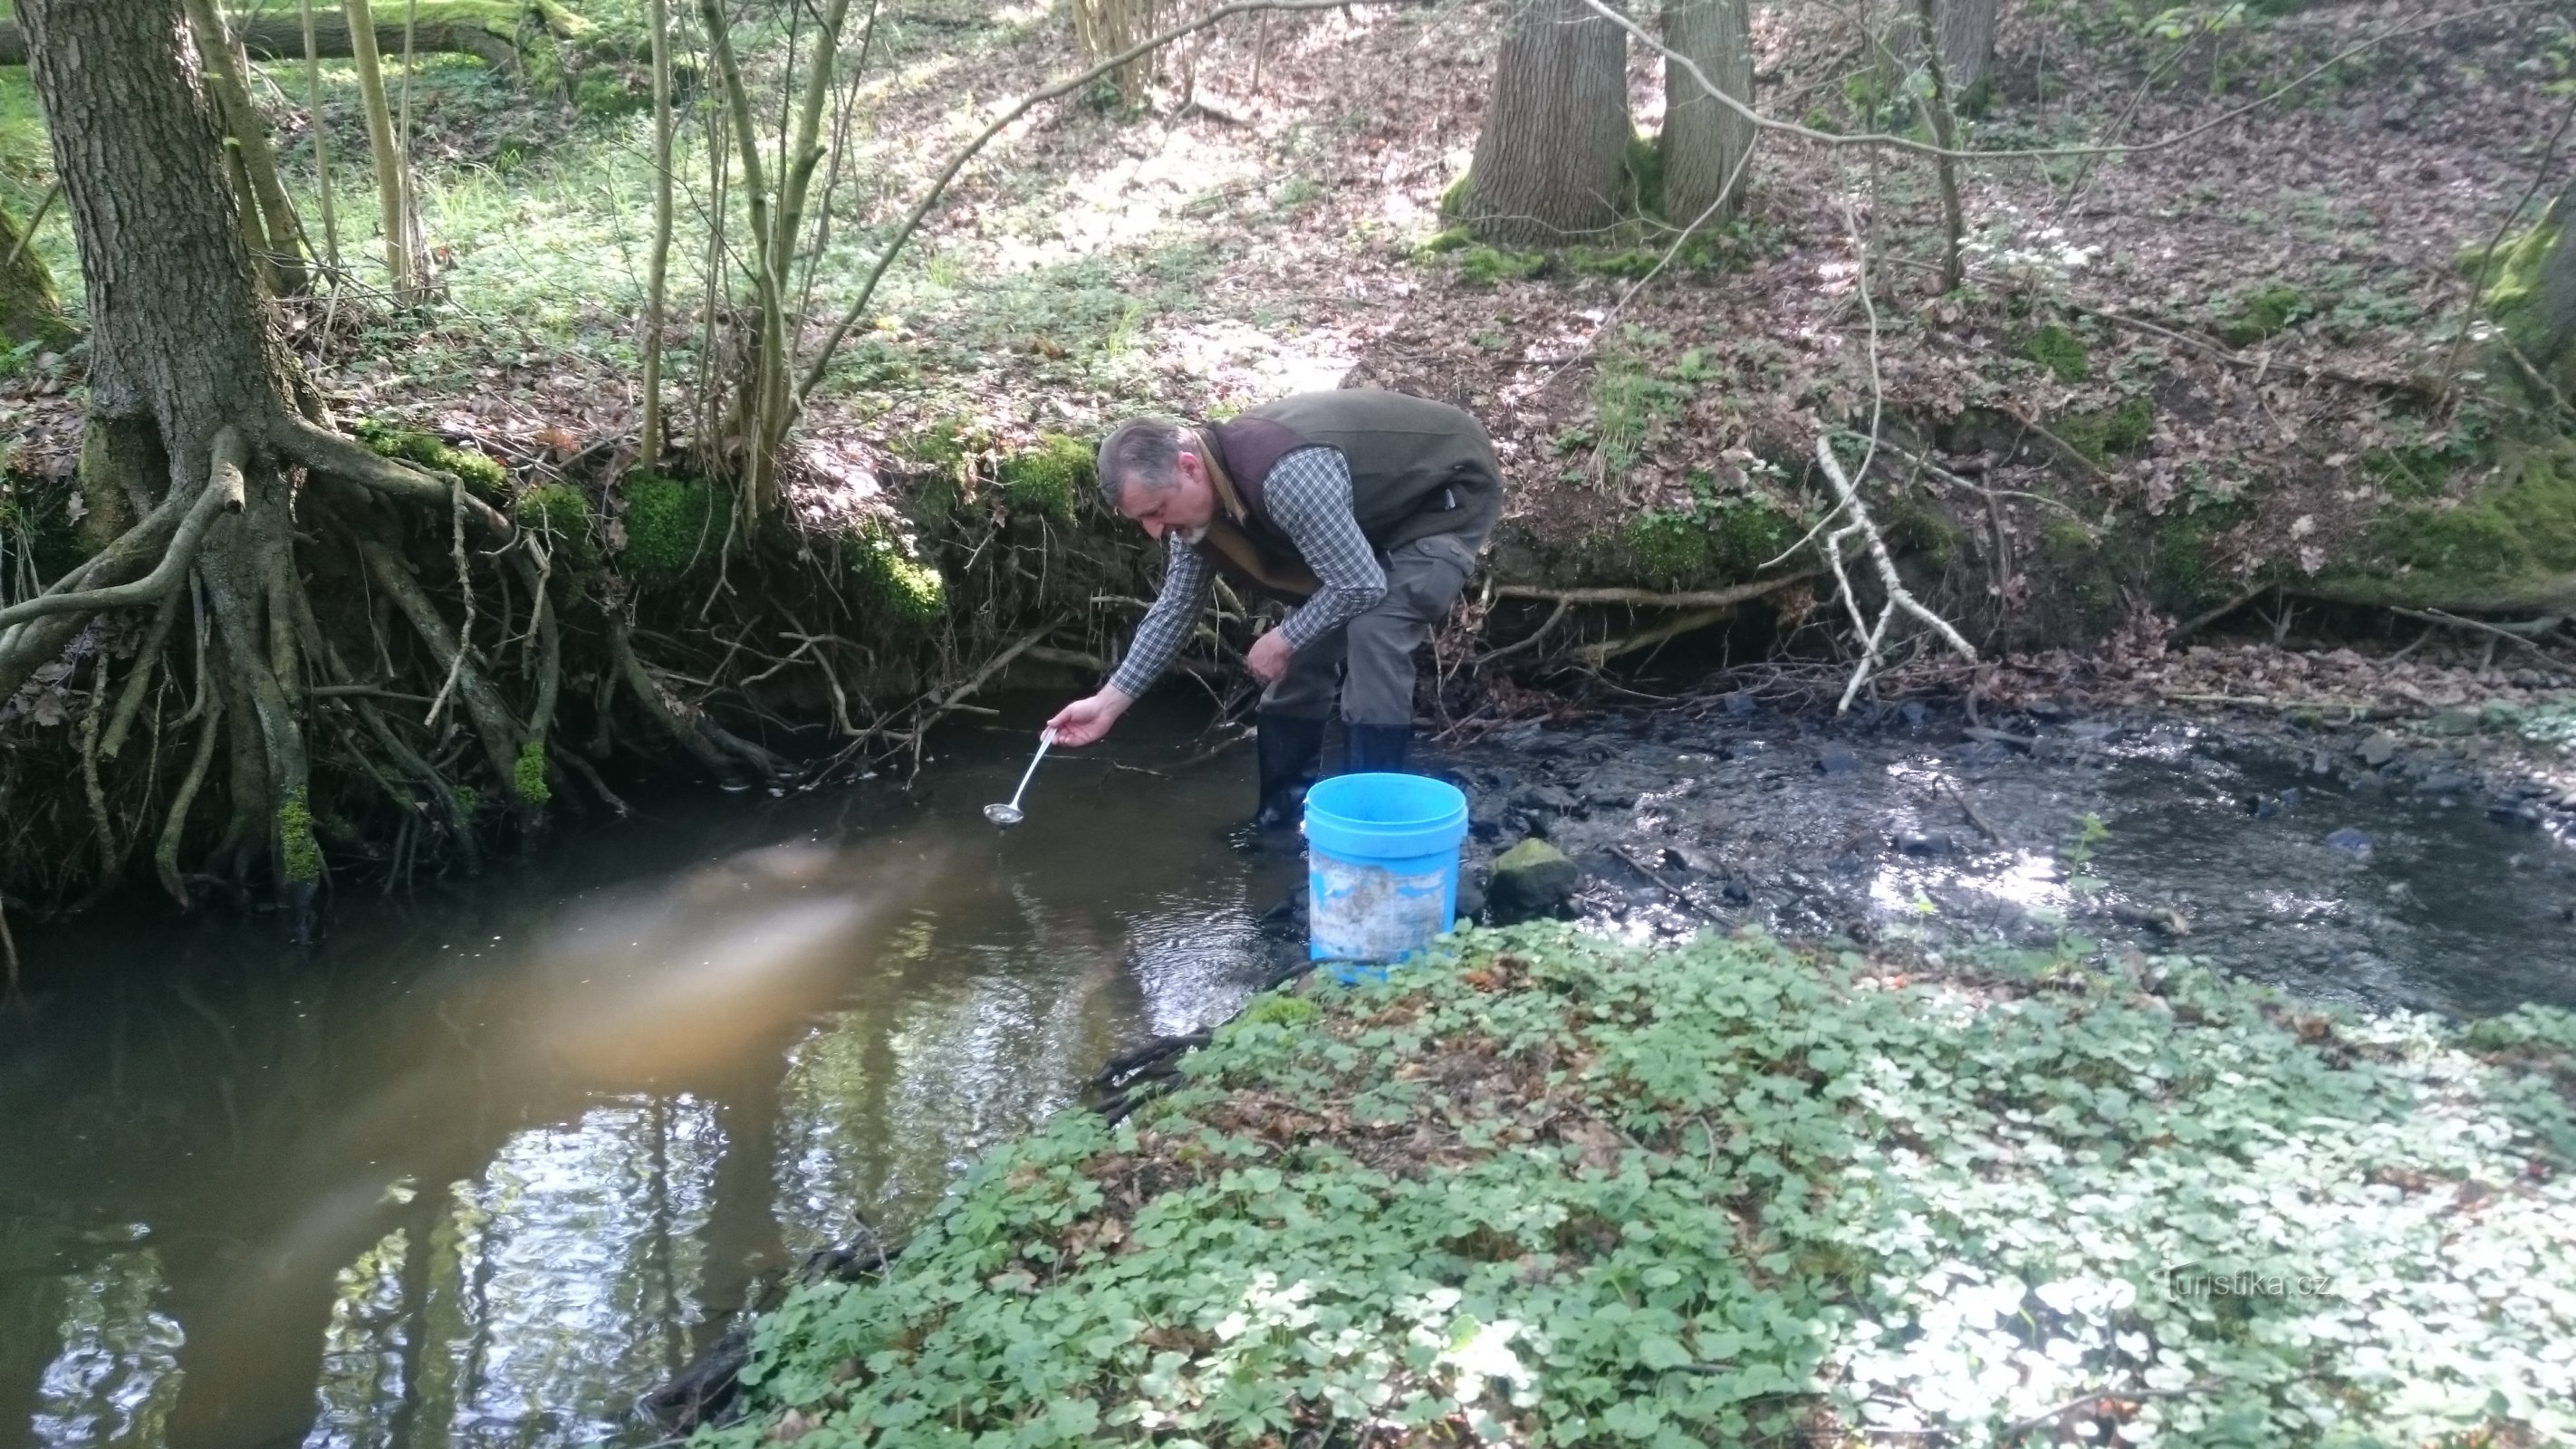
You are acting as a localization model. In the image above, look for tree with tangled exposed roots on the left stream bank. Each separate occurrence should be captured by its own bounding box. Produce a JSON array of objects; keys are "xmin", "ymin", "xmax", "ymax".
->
[{"xmin": 0, "ymin": 0, "xmax": 525, "ymax": 921}]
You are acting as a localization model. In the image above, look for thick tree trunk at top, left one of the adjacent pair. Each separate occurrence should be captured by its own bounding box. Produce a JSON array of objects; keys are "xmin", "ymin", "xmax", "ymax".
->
[{"xmin": 1466, "ymin": 0, "xmax": 1628, "ymax": 245}]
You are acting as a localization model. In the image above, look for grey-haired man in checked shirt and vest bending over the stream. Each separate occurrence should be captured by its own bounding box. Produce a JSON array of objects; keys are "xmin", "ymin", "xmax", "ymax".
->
[{"xmin": 1049, "ymin": 389, "xmax": 1502, "ymax": 829}]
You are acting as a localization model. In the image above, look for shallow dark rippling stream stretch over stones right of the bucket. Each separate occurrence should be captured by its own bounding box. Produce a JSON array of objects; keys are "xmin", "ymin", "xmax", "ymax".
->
[{"xmin": 1411, "ymin": 695, "xmax": 2576, "ymax": 1014}]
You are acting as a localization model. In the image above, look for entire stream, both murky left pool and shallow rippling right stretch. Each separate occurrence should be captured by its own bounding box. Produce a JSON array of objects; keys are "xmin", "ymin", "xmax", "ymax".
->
[{"xmin": 0, "ymin": 703, "xmax": 2576, "ymax": 1449}]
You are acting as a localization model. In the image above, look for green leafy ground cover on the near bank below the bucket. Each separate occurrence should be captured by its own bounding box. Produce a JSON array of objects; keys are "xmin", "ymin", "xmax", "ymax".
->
[{"xmin": 711, "ymin": 924, "xmax": 2576, "ymax": 1446}]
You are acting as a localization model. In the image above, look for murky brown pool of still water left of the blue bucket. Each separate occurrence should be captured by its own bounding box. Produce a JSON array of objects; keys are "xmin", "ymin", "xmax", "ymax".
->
[{"xmin": 0, "ymin": 705, "xmax": 1285, "ymax": 1449}]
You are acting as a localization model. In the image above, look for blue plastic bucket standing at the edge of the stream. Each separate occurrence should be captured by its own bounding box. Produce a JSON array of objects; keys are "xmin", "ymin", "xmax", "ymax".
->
[{"xmin": 1306, "ymin": 774, "xmax": 1466, "ymax": 978}]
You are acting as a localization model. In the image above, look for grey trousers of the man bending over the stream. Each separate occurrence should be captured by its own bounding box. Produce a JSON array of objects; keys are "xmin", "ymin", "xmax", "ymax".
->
[{"xmin": 1263, "ymin": 533, "xmax": 1478, "ymax": 725}]
